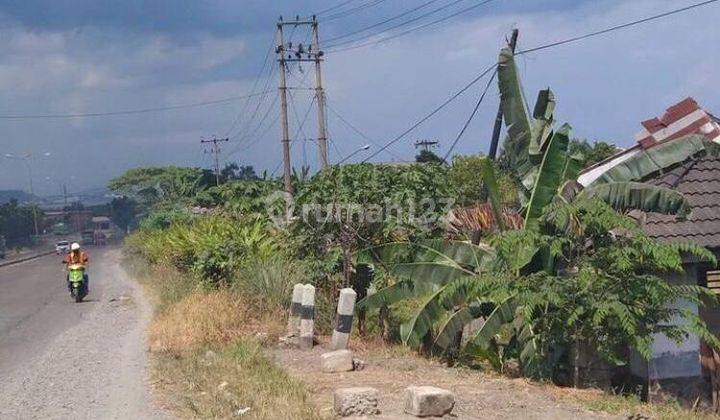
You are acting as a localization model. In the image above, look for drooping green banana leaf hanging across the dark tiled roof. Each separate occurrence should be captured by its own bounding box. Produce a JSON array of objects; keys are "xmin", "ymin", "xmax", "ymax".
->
[{"xmin": 576, "ymin": 182, "xmax": 691, "ymax": 219}]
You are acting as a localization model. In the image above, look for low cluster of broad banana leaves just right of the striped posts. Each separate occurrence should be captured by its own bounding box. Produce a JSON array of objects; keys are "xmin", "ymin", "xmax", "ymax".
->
[{"xmin": 357, "ymin": 239, "xmax": 495, "ymax": 351}]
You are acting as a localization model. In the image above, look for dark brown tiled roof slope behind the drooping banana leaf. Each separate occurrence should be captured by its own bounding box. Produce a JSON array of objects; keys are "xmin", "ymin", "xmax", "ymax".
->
[{"xmin": 643, "ymin": 156, "xmax": 720, "ymax": 248}]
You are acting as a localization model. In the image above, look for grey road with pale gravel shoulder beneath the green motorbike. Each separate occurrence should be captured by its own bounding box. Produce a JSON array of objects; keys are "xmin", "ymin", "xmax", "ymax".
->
[{"xmin": 0, "ymin": 249, "xmax": 166, "ymax": 419}]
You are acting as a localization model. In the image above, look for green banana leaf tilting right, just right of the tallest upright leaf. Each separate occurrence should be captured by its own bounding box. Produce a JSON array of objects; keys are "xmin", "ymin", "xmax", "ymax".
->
[{"xmin": 525, "ymin": 124, "xmax": 570, "ymax": 228}]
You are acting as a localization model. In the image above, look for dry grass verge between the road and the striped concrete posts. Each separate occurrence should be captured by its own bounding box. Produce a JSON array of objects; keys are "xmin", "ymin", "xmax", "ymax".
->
[{"xmin": 130, "ymin": 265, "xmax": 319, "ymax": 419}]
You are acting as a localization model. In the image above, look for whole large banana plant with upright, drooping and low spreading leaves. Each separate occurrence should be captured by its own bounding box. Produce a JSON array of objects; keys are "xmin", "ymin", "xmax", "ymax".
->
[{"xmin": 358, "ymin": 45, "xmax": 704, "ymax": 369}]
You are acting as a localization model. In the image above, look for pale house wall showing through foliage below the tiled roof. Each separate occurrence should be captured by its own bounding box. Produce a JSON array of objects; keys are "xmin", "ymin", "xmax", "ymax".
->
[{"xmin": 630, "ymin": 266, "xmax": 702, "ymax": 380}]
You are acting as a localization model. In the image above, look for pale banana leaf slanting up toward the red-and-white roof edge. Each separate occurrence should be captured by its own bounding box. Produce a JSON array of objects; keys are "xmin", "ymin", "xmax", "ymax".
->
[{"xmin": 587, "ymin": 134, "xmax": 716, "ymax": 187}]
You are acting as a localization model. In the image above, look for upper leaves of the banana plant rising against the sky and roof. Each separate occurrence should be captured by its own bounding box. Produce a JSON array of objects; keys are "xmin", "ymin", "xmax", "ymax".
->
[{"xmin": 496, "ymin": 48, "xmax": 692, "ymax": 228}]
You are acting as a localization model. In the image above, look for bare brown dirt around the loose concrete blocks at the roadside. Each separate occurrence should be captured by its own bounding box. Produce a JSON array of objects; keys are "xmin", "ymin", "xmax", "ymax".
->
[{"xmin": 275, "ymin": 338, "xmax": 613, "ymax": 419}]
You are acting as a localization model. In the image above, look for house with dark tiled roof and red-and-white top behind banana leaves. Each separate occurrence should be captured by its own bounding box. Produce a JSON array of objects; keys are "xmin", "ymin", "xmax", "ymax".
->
[{"xmin": 578, "ymin": 98, "xmax": 720, "ymax": 401}]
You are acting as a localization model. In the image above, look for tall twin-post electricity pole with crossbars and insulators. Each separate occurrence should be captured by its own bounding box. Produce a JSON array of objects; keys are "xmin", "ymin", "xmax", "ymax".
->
[{"xmin": 275, "ymin": 16, "xmax": 329, "ymax": 193}]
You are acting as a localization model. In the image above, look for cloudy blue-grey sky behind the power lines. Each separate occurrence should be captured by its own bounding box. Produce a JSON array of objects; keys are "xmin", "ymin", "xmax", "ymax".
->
[{"xmin": 0, "ymin": 0, "xmax": 720, "ymax": 194}]
